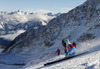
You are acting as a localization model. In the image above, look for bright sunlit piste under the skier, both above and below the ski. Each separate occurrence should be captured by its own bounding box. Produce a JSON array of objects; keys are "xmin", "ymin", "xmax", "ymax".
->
[{"xmin": 23, "ymin": 39, "xmax": 100, "ymax": 69}]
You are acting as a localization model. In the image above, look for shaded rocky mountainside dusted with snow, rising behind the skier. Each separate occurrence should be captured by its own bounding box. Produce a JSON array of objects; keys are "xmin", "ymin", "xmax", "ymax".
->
[{"xmin": 4, "ymin": 0, "xmax": 100, "ymax": 53}]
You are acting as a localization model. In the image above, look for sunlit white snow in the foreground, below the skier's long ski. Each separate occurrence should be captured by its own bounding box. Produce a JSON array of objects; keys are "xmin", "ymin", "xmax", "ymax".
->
[{"xmin": 43, "ymin": 51, "xmax": 100, "ymax": 69}]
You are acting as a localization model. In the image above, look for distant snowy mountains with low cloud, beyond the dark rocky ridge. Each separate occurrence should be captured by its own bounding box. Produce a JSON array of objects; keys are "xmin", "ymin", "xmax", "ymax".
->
[{"xmin": 0, "ymin": 10, "xmax": 60, "ymax": 46}]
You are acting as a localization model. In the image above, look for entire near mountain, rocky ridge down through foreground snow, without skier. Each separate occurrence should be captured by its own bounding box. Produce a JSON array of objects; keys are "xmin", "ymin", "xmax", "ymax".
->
[{"xmin": 0, "ymin": 0, "xmax": 100, "ymax": 69}]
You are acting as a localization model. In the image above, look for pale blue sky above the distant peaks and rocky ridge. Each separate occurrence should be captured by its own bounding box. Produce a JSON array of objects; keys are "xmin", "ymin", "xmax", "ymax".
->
[{"xmin": 0, "ymin": 0, "xmax": 86, "ymax": 13}]
